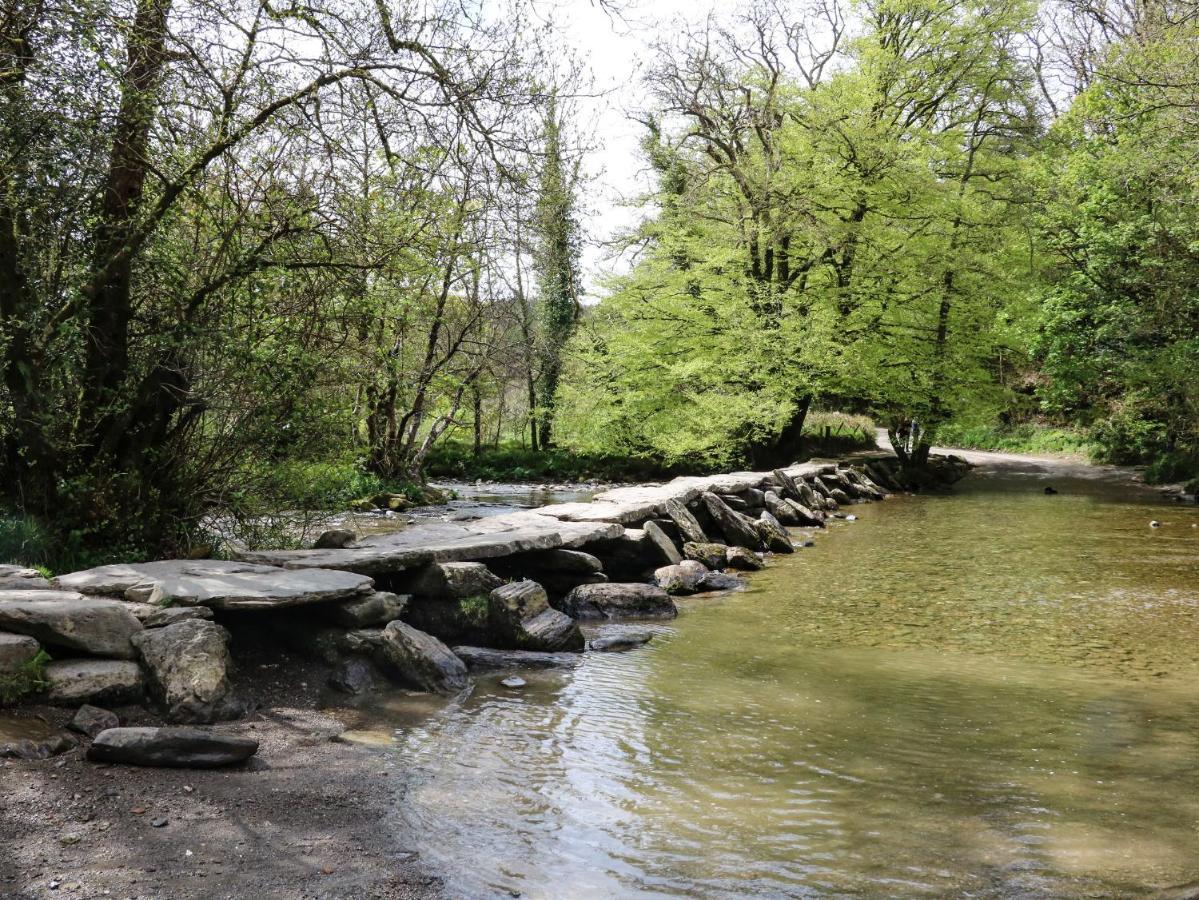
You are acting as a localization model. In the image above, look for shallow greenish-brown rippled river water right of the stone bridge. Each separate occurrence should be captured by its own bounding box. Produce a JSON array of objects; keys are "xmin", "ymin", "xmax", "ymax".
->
[{"xmin": 342, "ymin": 467, "xmax": 1199, "ymax": 898}]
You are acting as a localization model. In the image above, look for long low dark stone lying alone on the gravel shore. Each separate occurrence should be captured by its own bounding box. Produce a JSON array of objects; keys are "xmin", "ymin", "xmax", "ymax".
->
[{"xmin": 88, "ymin": 727, "xmax": 258, "ymax": 768}]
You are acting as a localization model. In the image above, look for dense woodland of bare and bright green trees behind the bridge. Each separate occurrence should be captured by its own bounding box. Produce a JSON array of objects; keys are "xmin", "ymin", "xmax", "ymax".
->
[{"xmin": 0, "ymin": 0, "xmax": 1199, "ymax": 561}]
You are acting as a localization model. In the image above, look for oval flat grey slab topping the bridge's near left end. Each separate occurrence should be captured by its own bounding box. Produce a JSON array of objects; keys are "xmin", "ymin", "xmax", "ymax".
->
[{"xmin": 55, "ymin": 563, "xmax": 373, "ymax": 610}]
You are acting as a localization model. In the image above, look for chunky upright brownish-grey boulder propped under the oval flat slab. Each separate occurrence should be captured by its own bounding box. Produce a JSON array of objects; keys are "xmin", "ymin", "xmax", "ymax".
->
[{"xmin": 133, "ymin": 618, "xmax": 241, "ymax": 724}]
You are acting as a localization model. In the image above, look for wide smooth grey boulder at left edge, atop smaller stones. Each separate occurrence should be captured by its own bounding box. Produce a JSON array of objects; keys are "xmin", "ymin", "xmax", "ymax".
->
[{"xmin": 0, "ymin": 591, "xmax": 141, "ymax": 659}]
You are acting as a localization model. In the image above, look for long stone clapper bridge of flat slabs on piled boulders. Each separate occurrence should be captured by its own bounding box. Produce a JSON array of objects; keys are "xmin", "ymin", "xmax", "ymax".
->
[{"xmin": 0, "ymin": 457, "xmax": 969, "ymax": 765}]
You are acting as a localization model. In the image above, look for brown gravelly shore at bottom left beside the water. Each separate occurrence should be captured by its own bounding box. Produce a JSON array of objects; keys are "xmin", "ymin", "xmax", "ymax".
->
[{"xmin": 0, "ymin": 653, "xmax": 440, "ymax": 900}]
